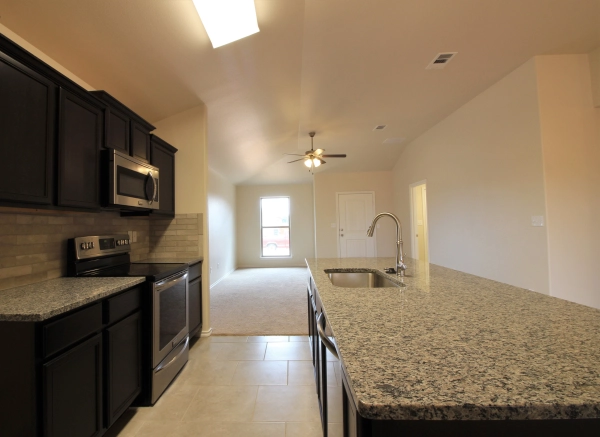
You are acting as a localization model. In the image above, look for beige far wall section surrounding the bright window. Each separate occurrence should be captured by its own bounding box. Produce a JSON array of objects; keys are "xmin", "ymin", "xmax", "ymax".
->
[{"xmin": 236, "ymin": 184, "xmax": 315, "ymax": 268}]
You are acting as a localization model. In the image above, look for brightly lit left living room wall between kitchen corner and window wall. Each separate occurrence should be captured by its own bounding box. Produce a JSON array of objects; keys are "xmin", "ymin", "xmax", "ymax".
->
[{"xmin": 208, "ymin": 169, "xmax": 236, "ymax": 287}]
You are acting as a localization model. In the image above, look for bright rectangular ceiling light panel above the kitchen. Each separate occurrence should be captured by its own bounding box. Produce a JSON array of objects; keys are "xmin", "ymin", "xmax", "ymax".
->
[{"xmin": 193, "ymin": 0, "xmax": 260, "ymax": 49}]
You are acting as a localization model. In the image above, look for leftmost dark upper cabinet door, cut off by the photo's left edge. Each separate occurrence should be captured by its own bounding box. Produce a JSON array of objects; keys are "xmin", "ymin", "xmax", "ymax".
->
[{"xmin": 0, "ymin": 53, "xmax": 56, "ymax": 205}]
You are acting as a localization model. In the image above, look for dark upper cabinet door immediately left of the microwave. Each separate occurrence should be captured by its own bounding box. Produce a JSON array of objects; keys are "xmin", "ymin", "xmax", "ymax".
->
[{"xmin": 58, "ymin": 89, "xmax": 104, "ymax": 209}]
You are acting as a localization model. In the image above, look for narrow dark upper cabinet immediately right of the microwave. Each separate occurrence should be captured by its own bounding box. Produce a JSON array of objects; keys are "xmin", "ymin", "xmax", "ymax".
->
[{"xmin": 150, "ymin": 135, "xmax": 177, "ymax": 216}]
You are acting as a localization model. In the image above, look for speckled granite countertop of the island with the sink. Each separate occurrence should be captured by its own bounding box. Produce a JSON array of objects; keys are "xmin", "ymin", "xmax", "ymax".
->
[{"xmin": 307, "ymin": 258, "xmax": 600, "ymax": 420}]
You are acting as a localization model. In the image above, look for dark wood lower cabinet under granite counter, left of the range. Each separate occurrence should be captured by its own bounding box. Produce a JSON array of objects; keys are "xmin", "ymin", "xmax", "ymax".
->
[{"xmin": 0, "ymin": 286, "xmax": 143, "ymax": 437}]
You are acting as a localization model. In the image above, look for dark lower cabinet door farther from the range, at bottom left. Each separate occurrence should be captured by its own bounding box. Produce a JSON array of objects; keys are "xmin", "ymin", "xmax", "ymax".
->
[{"xmin": 43, "ymin": 334, "xmax": 103, "ymax": 437}]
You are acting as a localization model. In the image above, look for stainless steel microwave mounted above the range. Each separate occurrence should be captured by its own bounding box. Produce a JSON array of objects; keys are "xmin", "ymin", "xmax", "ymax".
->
[{"xmin": 105, "ymin": 149, "xmax": 160, "ymax": 209}]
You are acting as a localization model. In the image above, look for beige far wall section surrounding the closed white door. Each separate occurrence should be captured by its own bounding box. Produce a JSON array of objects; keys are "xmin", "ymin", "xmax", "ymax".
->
[{"xmin": 314, "ymin": 171, "xmax": 398, "ymax": 258}]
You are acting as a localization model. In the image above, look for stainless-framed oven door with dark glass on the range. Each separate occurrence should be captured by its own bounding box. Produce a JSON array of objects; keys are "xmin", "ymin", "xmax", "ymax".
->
[{"xmin": 152, "ymin": 271, "xmax": 189, "ymax": 368}]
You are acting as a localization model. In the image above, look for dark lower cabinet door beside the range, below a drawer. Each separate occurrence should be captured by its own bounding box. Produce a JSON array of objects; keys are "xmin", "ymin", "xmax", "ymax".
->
[{"xmin": 105, "ymin": 311, "xmax": 142, "ymax": 426}]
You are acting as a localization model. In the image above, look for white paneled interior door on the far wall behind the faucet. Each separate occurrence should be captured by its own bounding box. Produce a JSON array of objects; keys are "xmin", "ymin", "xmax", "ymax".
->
[{"xmin": 338, "ymin": 193, "xmax": 376, "ymax": 258}]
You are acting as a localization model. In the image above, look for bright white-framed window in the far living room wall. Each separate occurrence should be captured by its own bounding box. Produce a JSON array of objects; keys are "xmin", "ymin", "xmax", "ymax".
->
[{"xmin": 260, "ymin": 197, "xmax": 291, "ymax": 257}]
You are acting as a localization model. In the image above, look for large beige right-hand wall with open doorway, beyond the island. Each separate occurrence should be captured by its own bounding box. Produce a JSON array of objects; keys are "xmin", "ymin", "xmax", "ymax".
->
[{"xmin": 393, "ymin": 60, "xmax": 548, "ymax": 294}]
